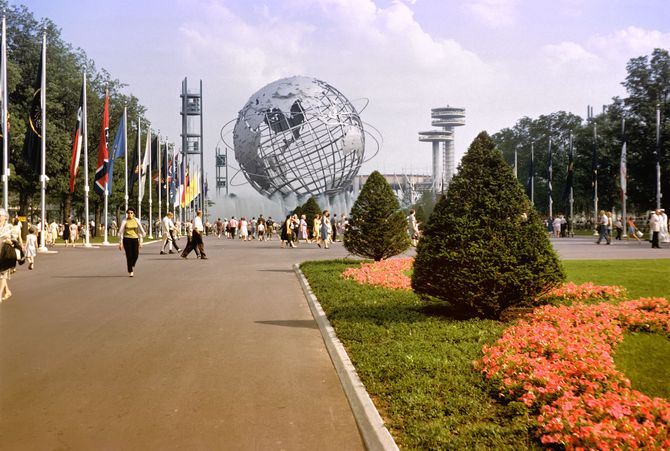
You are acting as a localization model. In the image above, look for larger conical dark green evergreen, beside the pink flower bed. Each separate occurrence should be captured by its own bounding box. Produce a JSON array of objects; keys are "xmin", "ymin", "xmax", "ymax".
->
[{"xmin": 412, "ymin": 132, "xmax": 565, "ymax": 318}]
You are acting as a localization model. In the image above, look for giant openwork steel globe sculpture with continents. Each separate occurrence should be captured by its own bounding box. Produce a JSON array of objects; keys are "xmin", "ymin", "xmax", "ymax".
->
[{"xmin": 233, "ymin": 76, "xmax": 365, "ymax": 197}]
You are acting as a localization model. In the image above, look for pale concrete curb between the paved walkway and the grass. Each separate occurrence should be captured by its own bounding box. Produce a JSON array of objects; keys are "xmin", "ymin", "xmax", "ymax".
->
[{"xmin": 293, "ymin": 264, "xmax": 399, "ymax": 451}]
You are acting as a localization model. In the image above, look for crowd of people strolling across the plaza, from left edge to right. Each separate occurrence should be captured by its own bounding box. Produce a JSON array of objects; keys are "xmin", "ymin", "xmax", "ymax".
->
[{"xmin": 0, "ymin": 207, "xmax": 670, "ymax": 302}]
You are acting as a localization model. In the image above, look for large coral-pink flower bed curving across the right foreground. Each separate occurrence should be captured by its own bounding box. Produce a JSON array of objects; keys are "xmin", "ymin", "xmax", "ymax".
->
[{"xmin": 475, "ymin": 298, "xmax": 670, "ymax": 449}]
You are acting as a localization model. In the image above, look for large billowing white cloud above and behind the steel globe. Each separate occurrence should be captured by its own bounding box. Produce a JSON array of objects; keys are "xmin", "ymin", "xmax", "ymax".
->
[{"xmin": 175, "ymin": 0, "xmax": 497, "ymax": 177}]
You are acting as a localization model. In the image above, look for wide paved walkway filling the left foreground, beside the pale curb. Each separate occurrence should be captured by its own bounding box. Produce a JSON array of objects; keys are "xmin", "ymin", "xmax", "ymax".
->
[{"xmin": 0, "ymin": 238, "xmax": 363, "ymax": 450}]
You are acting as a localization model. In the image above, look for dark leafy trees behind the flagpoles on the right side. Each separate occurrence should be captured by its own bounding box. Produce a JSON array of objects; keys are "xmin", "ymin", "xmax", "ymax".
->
[{"xmin": 492, "ymin": 49, "xmax": 670, "ymax": 216}]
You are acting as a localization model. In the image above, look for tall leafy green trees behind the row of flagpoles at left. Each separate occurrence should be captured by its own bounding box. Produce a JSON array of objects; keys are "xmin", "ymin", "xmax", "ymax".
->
[{"xmin": 0, "ymin": 0, "xmax": 148, "ymax": 219}]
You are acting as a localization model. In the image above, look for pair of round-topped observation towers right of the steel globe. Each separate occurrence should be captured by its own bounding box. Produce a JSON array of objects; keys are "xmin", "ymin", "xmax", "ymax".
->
[{"xmin": 419, "ymin": 105, "xmax": 465, "ymax": 193}]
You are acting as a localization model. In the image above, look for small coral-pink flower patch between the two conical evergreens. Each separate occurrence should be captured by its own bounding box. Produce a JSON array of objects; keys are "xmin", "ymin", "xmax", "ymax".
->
[{"xmin": 342, "ymin": 258, "xmax": 414, "ymax": 290}]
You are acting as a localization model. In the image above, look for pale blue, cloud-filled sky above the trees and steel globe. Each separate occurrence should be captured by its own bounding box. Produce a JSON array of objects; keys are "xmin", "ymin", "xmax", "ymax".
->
[{"xmin": 23, "ymin": 0, "xmax": 670, "ymax": 210}]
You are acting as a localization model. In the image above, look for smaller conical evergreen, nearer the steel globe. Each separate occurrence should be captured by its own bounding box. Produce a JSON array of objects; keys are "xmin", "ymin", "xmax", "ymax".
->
[{"xmin": 344, "ymin": 171, "xmax": 410, "ymax": 261}]
